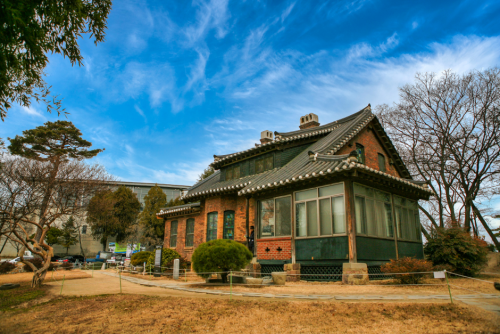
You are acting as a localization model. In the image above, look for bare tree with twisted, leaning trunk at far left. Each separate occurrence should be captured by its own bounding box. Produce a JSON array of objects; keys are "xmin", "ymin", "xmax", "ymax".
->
[{"xmin": 0, "ymin": 157, "xmax": 111, "ymax": 287}]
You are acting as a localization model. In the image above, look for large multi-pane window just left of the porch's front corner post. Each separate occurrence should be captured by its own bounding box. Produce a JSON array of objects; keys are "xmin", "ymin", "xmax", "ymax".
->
[{"xmin": 295, "ymin": 183, "xmax": 346, "ymax": 237}]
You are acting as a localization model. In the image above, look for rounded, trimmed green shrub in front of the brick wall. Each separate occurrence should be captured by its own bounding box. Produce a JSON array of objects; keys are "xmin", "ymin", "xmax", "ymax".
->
[{"xmin": 191, "ymin": 239, "xmax": 253, "ymax": 283}]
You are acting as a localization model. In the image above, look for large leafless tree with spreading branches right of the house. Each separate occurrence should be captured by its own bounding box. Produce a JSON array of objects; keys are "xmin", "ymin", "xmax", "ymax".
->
[{"xmin": 378, "ymin": 68, "xmax": 500, "ymax": 250}]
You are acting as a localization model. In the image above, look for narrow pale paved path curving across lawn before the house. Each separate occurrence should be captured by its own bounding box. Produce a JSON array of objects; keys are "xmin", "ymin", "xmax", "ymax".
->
[{"xmin": 103, "ymin": 272, "xmax": 500, "ymax": 315}]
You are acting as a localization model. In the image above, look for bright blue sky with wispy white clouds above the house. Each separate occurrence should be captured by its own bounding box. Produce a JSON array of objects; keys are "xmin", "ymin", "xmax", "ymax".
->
[{"xmin": 0, "ymin": 0, "xmax": 500, "ymax": 204}]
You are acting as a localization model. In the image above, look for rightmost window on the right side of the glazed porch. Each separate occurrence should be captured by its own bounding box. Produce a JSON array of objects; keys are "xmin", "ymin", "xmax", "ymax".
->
[{"xmin": 394, "ymin": 196, "xmax": 422, "ymax": 241}]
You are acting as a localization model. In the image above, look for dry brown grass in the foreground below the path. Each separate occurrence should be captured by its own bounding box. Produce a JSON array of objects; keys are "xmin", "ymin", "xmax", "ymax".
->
[{"xmin": 0, "ymin": 295, "xmax": 500, "ymax": 333}]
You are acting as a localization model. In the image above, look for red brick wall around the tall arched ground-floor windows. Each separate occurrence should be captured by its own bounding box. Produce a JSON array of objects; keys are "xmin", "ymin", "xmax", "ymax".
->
[{"xmin": 163, "ymin": 195, "xmax": 255, "ymax": 261}]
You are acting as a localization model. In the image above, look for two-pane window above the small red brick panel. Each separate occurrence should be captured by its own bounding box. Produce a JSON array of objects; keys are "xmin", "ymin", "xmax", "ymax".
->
[{"xmin": 259, "ymin": 196, "xmax": 292, "ymax": 238}]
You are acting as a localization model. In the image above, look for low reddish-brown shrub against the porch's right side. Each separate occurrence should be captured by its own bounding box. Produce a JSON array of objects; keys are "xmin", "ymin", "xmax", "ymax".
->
[{"xmin": 380, "ymin": 257, "xmax": 432, "ymax": 284}]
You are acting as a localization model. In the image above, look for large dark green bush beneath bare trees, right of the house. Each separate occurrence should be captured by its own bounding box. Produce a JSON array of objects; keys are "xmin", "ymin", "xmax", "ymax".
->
[{"xmin": 424, "ymin": 227, "xmax": 488, "ymax": 276}]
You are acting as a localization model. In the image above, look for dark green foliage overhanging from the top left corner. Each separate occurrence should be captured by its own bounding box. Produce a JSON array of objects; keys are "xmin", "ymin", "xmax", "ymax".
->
[{"xmin": 0, "ymin": 0, "xmax": 111, "ymax": 121}]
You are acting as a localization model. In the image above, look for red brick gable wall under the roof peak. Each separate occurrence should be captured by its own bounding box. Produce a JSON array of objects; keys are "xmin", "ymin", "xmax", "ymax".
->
[{"xmin": 335, "ymin": 122, "xmax": 400, "ymax": 177}]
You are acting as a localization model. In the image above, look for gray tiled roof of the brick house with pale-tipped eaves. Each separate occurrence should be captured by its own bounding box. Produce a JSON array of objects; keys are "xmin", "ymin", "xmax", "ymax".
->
[{"xmin": 185, "ymin": 106, "xmax": 429, "ymax": 199}]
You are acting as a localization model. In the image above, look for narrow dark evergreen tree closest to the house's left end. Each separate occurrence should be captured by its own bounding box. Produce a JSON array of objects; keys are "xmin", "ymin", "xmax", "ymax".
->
[{"xmin": 139, "ymin": 185, "xmax": 167, "ymax": 245}]
